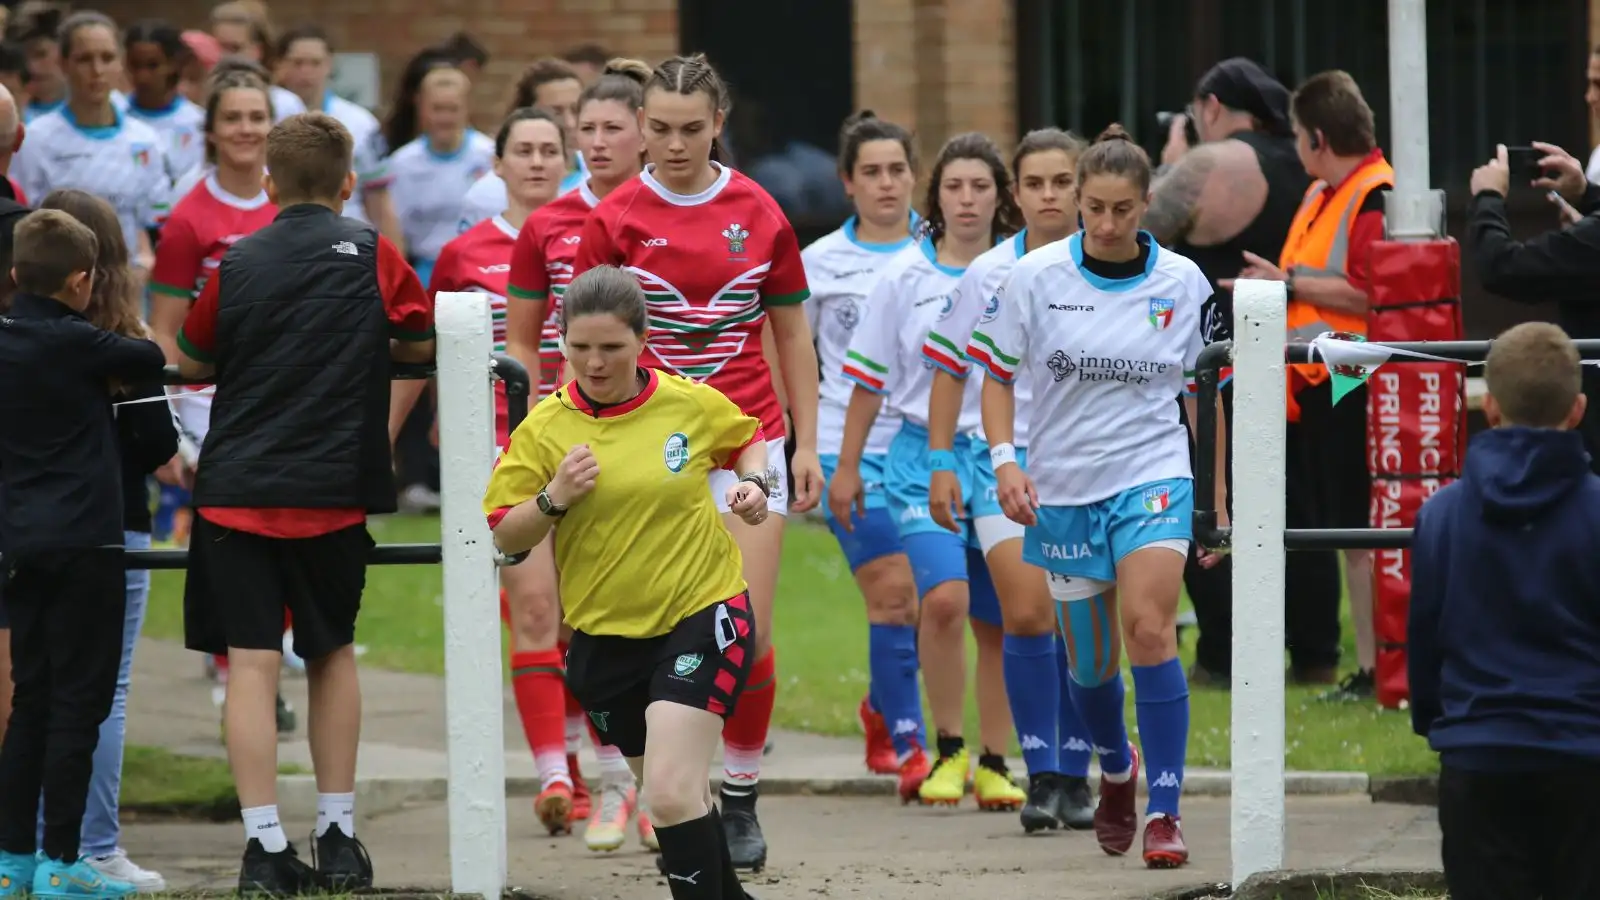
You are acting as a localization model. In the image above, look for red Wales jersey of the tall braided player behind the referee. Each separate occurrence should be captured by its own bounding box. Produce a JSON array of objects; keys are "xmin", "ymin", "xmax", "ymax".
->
[{"xmin": 573, "ymin": 167, "xmax": 810, "ymax": 440}]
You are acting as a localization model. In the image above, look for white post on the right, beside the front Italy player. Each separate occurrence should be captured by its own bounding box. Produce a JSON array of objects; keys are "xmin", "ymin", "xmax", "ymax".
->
[{"xmin": 1232, "ymin": 279, "xmax": 1288, "ymax": 889}]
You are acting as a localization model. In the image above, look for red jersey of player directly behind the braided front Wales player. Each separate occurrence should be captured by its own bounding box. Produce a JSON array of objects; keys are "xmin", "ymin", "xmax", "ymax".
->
[{"xmin": 506, "ymin": 179, "xmax": 600, "ymax": 397}]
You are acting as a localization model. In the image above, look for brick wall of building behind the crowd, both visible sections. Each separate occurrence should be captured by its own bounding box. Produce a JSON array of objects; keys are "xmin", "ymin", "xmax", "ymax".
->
[{"xmin": 85, "ymin": 0, "xmax": 1011, "ymax": 159}]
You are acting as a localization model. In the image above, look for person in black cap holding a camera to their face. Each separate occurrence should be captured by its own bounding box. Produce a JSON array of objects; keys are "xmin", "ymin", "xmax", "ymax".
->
[{"xmin": 1144, "ymin": 58, "xmax": 1310, "ymax": 687}]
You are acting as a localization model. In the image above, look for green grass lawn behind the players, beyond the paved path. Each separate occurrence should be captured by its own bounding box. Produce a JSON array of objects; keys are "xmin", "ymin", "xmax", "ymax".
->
[{"xmin": 146, "ymin": 516, "xmax": 1438, "ymax": 775}]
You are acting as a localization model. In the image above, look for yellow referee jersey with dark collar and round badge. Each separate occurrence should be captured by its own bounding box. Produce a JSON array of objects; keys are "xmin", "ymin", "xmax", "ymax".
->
[{"xmin": 483, "ymin": 368, "xmax": 763, "ymax": 637}]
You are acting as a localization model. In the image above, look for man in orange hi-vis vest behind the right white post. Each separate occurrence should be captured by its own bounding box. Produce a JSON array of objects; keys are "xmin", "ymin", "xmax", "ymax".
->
[{"xmin": 1240, "ymin": 70, "xmax": 1395, "ymax": 695}]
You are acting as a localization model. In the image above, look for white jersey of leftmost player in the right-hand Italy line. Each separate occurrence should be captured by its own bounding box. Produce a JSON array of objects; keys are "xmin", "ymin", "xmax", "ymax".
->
[{"xmin": 800, "ymin": 216, "xmax": 915, "ymax": 455}]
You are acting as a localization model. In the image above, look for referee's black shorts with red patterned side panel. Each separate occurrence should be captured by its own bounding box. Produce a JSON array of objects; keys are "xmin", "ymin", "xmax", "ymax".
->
[{"xmin": 566, "ymin": 591, "xmax": 755, "ymax": 757}]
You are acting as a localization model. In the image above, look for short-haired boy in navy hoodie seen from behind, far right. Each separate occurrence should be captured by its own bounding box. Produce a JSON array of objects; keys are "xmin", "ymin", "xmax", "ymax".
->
[{"xmin": 1410, "ymin": 322, "xmax": 1600, "ymax": 900}]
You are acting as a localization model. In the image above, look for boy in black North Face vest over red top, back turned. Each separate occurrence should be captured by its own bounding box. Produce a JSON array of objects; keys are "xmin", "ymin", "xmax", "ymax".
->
[{"xmin": 178, "ymin": 112, "xmax": 434, "ymax": 895}]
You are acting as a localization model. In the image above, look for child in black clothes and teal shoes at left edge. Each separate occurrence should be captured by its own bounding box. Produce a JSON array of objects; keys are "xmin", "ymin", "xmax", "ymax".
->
[{"xmin": 0, "ymin": 210, "xmax": 166, "ymax": 897}]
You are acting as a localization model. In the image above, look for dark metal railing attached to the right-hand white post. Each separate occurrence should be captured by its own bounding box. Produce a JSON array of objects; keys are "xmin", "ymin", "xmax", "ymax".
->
[{"xmin": 1194, "ymin": 340, "xmax": 1600, "ymax": 549}]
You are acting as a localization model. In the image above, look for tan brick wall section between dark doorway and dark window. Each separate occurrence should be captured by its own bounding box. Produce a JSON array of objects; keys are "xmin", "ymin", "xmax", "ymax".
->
[{"xmin": 854, "ymin": 0, "xmax": 1011, "ymax": 172}]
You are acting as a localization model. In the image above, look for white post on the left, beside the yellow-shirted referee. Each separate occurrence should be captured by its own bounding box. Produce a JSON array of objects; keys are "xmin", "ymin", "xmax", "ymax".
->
[{"xmin": 434, "ymin": 293, "xmax": 506, "ymax": 900}]
